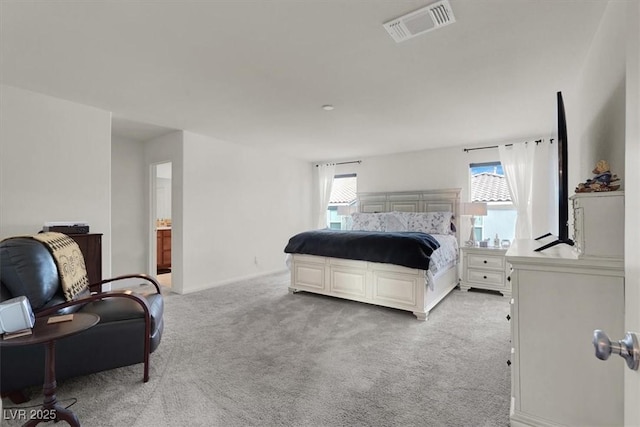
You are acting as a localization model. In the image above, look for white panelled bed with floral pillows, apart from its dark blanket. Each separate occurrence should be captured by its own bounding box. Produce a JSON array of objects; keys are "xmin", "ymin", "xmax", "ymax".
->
[{"xmin": 285, "ymin": 188, "xmax": 460, "ymax": 320}]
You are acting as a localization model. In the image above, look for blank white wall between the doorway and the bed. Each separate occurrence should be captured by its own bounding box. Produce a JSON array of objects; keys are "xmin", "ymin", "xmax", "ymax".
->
[{"xmin": 180, "ymin": 132, "xmax": 312, "ymax": 292}]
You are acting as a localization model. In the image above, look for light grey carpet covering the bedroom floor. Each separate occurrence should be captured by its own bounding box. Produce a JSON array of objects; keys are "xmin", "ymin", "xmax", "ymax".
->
[{"xmin": 3, "ymin": 273, "xmax": 510, "ymax": 427}]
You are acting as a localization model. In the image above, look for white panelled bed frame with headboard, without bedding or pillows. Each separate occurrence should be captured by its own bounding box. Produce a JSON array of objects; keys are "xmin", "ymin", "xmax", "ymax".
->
[{"xmin": 289, "ymin": 188, "xmax": 460, "ymax": 320}]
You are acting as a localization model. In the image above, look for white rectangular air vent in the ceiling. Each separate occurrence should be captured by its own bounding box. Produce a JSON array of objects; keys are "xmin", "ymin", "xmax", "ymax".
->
[{"xmin": 383, "ymin": 0, "xmax": 456, "ymax": 43}]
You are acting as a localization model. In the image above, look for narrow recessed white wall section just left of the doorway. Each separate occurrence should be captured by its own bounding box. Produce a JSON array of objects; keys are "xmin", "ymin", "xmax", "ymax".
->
[{"xmin": 111, "ymin": 137, "xmax": 148, "ymax": 280}]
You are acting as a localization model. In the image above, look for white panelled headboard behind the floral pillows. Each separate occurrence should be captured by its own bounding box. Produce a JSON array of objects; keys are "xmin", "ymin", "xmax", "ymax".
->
[{"xmin": 357, "ymin": 188, "xmax": 461, "ymax": 238}]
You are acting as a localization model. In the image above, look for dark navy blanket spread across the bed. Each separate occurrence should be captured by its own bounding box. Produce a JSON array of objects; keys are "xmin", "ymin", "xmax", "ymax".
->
[{"xmin": 284, "ymin": 229, "xmax": 440, "ymax": 270}]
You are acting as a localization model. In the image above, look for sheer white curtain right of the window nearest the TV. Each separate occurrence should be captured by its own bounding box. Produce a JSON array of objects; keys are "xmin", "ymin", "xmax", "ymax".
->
[{"xmin": 498, "ymin": 143, "xmax": 535, "ymax": 239}]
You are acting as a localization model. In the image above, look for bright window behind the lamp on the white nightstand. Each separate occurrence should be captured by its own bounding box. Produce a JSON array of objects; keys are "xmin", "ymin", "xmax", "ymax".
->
[{"xmin": 469, "ymin": 162, "xmax": 517, "ymax": 246}]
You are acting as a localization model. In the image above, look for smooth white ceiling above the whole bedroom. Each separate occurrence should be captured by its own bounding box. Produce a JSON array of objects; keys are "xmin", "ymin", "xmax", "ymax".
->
[{"xmin": 0, "ymin": 0, "xmax": 607, "ymax": 161}]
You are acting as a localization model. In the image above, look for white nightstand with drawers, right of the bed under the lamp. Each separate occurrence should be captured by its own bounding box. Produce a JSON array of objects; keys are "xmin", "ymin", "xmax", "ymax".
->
[{"xmin": 460, "ymin": 247, "xmax": 511, "ymax": 298}]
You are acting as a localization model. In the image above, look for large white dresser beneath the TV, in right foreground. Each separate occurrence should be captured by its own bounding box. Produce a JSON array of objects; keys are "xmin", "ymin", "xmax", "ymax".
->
[{"xmin": 506, "ymin": 240, "xmax": 624, "ymax": 427}]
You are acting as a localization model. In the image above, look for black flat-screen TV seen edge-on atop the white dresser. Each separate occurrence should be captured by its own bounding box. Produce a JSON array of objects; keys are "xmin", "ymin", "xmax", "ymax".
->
[{"xmin": 536, "ymin": 92, "xmax": 573, "ymax": 251}]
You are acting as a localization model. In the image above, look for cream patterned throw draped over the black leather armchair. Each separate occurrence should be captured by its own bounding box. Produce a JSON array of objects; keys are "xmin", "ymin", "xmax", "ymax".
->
[{"xmin": 29, "ymin": 232, "xmax": 89, "ymax": 301}]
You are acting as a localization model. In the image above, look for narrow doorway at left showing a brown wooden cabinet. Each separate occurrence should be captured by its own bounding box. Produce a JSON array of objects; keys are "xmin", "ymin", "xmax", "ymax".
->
[{"xmin": 151, "ymin": 162, "xmax": 172, "ymax": 288}]
